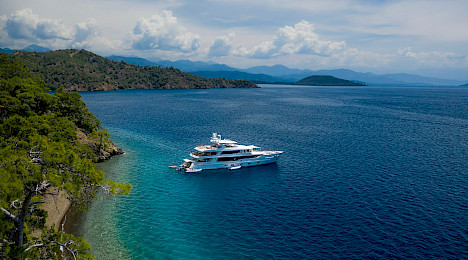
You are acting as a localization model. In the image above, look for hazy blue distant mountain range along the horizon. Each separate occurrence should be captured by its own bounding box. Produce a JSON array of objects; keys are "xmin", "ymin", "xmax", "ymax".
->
[{"xmin": 108, "ymin": 56, "xmax": 466, "ymax": 86}]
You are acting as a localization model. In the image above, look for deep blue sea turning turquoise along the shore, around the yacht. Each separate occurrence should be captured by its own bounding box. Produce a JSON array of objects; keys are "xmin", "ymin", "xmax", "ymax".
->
[{"xmin": 70, "ymin": 85, "xmax": 468, "ymax": 259}]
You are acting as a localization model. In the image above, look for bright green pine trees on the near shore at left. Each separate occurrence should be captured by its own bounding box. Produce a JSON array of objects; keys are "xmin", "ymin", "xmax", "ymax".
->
[{"xmin": 0, "ymin": 54, "xmax": 131, "ymax": 259}]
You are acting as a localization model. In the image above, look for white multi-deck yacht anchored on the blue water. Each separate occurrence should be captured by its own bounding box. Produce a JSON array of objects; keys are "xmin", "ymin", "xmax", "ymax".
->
[{"xmin": 171, "ymin": 133, "xmax": 283, "ymax": 172}]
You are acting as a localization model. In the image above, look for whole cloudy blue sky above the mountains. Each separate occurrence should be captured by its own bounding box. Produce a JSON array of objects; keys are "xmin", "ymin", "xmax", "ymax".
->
[{"xmin": 0, "ymin": 0, "xmax": 468, "ymax": 81}]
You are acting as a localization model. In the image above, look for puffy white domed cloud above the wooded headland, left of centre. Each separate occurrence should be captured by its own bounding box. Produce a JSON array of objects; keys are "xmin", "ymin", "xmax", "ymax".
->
[{"xmin": 131, "ymin": 10, "xmax": 199, "ymax": 53}]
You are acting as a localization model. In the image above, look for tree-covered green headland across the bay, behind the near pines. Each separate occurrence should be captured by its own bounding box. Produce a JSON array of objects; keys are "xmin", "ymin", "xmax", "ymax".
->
[{"xmin": 5, "ymin": 50, "xmax": 258, "ymax": 91}]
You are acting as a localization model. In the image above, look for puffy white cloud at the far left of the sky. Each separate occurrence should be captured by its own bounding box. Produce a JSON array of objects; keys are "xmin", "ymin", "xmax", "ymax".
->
[{"xmin": 5, "ymin": 9, "xmax": 70, "ymax": 40}]
